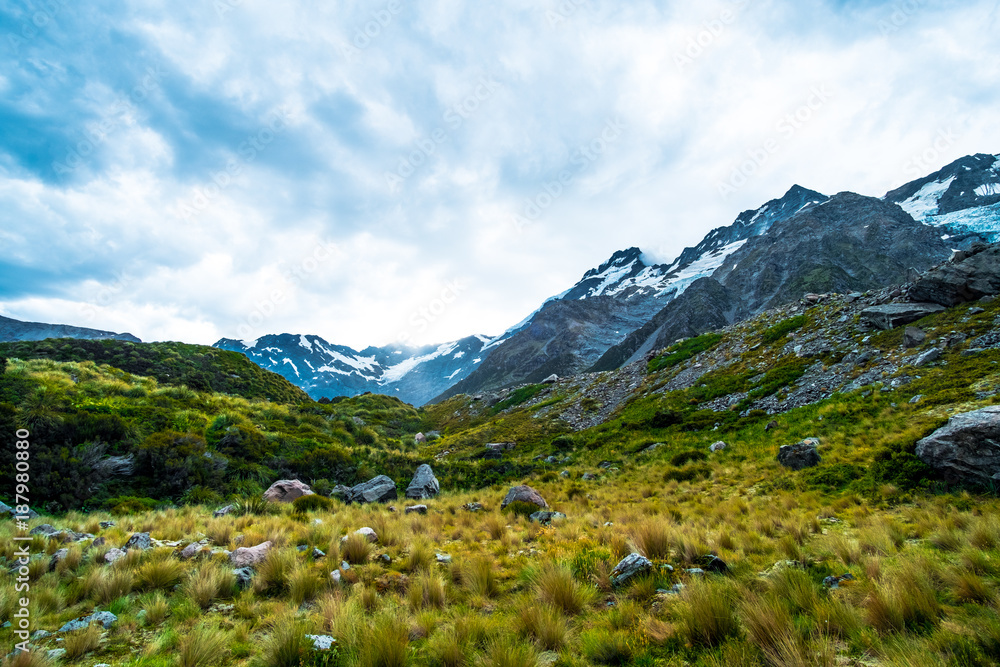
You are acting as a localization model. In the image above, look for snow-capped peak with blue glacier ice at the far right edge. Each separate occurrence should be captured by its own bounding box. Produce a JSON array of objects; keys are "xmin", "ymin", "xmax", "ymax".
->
[{"xmin": 884, "ymin": 154, "xmax": 1000, "ymax": 241}]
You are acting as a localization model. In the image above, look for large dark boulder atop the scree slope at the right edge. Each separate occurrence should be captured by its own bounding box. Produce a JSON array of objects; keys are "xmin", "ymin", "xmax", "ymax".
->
[{"xmin": 907, "ymin": 244, "xmax": 1000, "ymax": 307}]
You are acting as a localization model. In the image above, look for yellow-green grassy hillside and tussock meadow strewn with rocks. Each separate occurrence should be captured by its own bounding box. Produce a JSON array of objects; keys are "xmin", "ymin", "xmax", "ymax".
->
[{"xmin": 0, "ymin": 300, "xmax": 1000, "ymax": 667}]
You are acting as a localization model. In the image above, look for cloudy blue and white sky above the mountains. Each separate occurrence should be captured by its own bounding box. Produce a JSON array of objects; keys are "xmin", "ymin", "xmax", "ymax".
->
[{"xmin": 0, "ymin": 0, "xmax": 1000, "ymax": 349}]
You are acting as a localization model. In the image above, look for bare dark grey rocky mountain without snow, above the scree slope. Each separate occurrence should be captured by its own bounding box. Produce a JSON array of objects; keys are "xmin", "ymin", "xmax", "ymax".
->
[{"xmin": 590, "ymin": 192, "xmax": 951, "ymax": 371}]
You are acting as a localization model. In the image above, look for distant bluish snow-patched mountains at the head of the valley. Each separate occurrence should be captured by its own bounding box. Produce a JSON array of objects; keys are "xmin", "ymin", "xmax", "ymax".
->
[{"xmin": 215, "ymin": 334, "xmax": 491, "ymax": 405}]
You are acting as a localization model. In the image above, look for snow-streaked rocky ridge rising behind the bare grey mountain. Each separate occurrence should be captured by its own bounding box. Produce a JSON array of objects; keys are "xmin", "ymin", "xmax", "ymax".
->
[{"xmin": 440, "ymin": 185, "xmax": 827, "ymax": 398}]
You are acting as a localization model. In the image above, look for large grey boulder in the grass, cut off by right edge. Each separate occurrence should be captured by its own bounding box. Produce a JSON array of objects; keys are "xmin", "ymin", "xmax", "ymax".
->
[{"xmin": 917, "ymin": 405, "xmax": 1000, "ymax": 483}]
